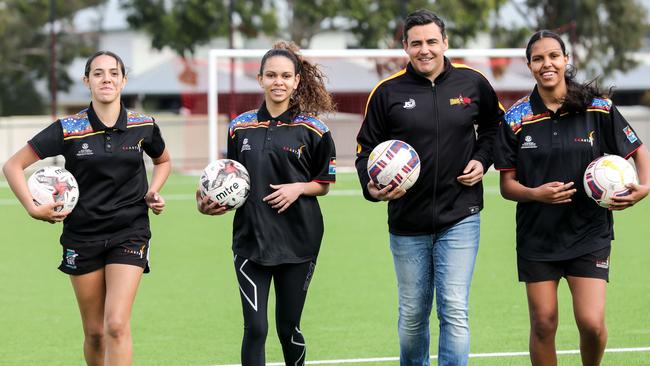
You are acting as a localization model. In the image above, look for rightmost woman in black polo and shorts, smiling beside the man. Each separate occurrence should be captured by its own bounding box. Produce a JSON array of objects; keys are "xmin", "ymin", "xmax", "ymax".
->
[{"xmin": 494, "ymin": 30, "xmax": 650, "ymax": 365}]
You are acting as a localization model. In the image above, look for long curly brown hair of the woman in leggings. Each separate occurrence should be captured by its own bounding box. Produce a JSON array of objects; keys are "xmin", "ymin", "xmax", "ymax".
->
[{"xmin": 259, "ymin": 41, "xmax": 336, "ymax": 116}]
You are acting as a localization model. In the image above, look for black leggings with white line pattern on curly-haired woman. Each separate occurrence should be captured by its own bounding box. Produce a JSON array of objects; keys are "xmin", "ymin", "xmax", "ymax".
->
[{"xmin": 235, "ymin": 256, "xmax": 316, "ymax": 366}]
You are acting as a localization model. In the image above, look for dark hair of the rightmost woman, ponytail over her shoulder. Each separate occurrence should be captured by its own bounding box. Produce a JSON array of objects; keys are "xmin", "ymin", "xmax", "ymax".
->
[{"xmin": 526, "ymin": 29, "xmax": 611, "ymax": 113}]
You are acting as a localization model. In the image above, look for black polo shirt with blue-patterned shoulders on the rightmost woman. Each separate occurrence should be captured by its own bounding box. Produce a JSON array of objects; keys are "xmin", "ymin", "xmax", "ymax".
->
[{"xmin": 494, "ymin": 88, "xmax": 642, "ymax": 261}]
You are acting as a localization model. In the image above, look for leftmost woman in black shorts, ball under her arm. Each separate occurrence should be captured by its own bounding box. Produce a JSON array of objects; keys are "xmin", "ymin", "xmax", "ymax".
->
[{"xmin": 3, "ymin": 51, "xmax": 171, "ymax": 365}]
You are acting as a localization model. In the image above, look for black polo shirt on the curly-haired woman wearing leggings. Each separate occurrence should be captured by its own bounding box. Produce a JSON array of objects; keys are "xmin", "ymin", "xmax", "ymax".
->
[{"xmin": 228, "ymin": 104, "xmax": 336, "ymax": 265}]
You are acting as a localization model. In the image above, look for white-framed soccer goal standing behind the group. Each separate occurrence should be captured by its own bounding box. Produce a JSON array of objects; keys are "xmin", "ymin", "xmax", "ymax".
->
[{"xmin": 208, "ymin": 48, "xmax": 533, "ymax": 162}]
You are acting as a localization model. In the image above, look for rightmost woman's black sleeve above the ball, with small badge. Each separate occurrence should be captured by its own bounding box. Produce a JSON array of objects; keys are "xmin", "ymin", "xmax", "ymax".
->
[{"xmin": 602, "ymin": 106, "xmax": 643, "ymax": 158}]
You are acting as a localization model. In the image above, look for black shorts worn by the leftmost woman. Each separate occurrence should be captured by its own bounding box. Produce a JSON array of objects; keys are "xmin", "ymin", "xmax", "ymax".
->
[{"xmin": 59, "ymin": 234, "xmax": 150, "ymax": 275}]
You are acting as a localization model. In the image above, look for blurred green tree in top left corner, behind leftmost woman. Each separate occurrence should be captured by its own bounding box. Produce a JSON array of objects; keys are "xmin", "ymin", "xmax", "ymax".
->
[{"xmin": 0, "ymin": 0, "xmax": 104, "ymax": 116}]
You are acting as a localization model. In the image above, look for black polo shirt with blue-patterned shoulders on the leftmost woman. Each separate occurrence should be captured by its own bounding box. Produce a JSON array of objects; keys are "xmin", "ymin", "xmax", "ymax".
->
[{"xmin": 28, "ymin": 104, "xmax": 165, "ymax": 242}]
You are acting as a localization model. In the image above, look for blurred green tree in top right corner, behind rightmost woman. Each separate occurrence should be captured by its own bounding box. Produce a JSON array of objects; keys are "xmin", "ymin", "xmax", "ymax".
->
[{"xmin": 493, "ymin": 0, "xmax": 648, "ymax": 76}]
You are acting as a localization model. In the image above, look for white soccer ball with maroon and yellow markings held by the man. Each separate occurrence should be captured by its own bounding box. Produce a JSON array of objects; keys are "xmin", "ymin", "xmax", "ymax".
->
[{"xmin": 367, "ymin": 140, "xmax": 420, "ymax": 189}]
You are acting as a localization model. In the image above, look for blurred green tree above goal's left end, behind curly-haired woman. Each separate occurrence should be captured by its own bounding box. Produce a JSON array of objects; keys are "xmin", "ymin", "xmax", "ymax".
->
[{"xmin": 121, "ymin": 0, "xmax": 277, "ymax": 58}]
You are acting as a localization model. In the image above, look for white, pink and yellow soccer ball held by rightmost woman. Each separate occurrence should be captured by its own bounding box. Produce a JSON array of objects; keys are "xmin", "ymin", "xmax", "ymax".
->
[{"xmin": 583, "ymin": 155, "xmax": 639, "ymax": 208}]
